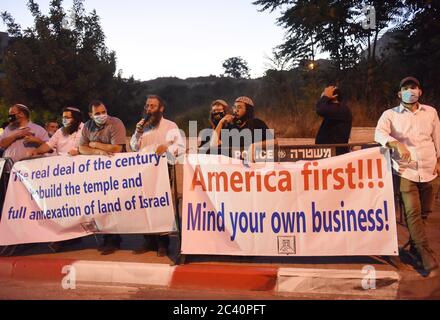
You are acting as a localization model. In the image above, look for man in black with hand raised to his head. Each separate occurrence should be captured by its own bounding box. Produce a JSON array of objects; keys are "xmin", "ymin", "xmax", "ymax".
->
[{"xmin": 315, "ymin": 86, "xmax": 353, "ymax": 155}]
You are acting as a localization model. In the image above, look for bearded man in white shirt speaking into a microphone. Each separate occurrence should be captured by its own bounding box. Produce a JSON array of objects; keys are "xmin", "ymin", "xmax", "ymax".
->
[{"xmin": 130, "ymin": 95, "xmax": 185, "ymax": 257}]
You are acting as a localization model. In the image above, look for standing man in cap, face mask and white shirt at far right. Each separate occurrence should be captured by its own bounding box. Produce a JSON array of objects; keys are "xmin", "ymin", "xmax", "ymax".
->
[{"xmin": 375, "ymin": 77, "xmax": 440, "ymax": 276}]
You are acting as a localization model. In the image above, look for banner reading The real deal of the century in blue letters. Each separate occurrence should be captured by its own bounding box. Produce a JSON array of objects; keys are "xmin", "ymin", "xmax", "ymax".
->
[{"xmin": 0, "ymin": 153, "xmax": 176, "ymax": 245}]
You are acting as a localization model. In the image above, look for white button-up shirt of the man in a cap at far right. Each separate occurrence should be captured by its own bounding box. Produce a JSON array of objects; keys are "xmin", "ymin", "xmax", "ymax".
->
[{"xmin": 375, "ymin": 104, "xmax": 440, "ymax": 182}]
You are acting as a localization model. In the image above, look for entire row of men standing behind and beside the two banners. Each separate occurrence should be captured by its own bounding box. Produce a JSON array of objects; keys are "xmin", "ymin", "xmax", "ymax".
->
[{"xmin": 0, "ymin": 77, "xmax": 440, "ymax": 273}]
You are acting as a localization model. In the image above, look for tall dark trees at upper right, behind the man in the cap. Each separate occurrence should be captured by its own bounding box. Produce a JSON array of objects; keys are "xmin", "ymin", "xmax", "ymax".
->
[{"xmin": 253, "ymin": 0, "xmax": 440, "ymax": 112}]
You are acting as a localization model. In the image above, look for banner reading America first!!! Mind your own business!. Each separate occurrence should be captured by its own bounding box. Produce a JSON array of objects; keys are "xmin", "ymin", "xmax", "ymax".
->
[{"xmin": 182, "ymin": 148, "xmax": 398, "ymax": 256}]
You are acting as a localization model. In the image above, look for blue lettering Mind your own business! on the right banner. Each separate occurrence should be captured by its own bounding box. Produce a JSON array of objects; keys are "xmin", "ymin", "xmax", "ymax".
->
[{"xmin": 186, "ymin": 201, "xmax": 390, "ymax": 241}]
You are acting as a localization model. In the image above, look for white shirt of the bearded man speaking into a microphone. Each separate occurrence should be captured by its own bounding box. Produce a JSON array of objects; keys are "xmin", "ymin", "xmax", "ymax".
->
[{"xmin": 130, "ymin": 118, "xmax": 185, "ymax": 157}]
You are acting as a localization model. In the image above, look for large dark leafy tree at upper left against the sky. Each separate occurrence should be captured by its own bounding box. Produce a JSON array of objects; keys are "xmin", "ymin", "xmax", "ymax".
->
[{"xmin": 1, "ymin": 0, "xmax": 116, "ymax": 122}]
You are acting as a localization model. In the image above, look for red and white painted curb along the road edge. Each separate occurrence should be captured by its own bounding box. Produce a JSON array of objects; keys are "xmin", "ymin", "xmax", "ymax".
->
[{"xmin": 0, "ymin": 257, "xmax": 400, "ymax": 298}]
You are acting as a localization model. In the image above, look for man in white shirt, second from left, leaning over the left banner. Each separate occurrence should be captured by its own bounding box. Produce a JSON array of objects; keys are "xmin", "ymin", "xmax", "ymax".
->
[{"xmin": 29, "ymin": 107, "xmax": 84, "ymax": 157}]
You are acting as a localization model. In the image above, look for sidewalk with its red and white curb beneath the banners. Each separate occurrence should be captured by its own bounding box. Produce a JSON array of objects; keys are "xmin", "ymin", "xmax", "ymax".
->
[{"xmin": 0, "ymin": 203, "xmax": 440, "ymax": 299}]
